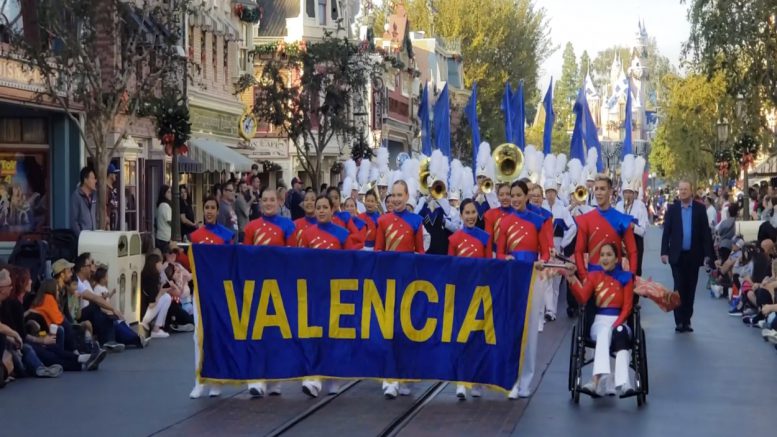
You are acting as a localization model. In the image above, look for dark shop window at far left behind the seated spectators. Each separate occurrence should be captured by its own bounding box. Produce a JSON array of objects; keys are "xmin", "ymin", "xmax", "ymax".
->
[{"xmin": 0, "ymin": 148, "xmax": 51, "ymax": 241}]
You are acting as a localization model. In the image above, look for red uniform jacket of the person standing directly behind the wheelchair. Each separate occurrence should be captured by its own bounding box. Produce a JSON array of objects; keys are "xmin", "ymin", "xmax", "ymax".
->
[{"xmin": 575, "ymin": 208, "xmax": 637, "ymax": 279}]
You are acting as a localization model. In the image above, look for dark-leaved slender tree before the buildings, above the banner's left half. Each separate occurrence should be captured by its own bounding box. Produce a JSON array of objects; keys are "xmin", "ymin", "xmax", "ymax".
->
[{"xmin": 246, "ymin": 34, "xmax": 383, "ymax": 187}]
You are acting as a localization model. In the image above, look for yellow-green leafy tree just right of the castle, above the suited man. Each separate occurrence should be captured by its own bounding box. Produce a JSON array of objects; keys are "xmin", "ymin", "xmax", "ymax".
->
[{"xmin": 650, "ymin": 74, "xmax": 739, "ymax": 181}]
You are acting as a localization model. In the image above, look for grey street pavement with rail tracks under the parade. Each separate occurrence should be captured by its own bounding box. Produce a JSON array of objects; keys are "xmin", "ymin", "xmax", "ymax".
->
[{"xmin": 0, "ymin": 229, "xmax": 777, "ymax": 437}]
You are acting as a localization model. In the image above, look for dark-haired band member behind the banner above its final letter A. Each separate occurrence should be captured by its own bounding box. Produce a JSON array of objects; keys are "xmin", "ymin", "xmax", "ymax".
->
[{"xmin": 448, "ymin": 199, "xmax": 493, "ymax": 400}]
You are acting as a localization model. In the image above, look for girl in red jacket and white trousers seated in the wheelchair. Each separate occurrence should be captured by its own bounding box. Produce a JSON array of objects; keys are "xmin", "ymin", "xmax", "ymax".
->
[{"xmin": 565, "ymin": 243, "xmax": 634, "ymax": 397}]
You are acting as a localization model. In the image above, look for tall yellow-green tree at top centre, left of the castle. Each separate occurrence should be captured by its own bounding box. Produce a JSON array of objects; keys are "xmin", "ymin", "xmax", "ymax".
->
[{"xmin": 400, "ymin": 0, "xmax": 553, "ymax": 142}]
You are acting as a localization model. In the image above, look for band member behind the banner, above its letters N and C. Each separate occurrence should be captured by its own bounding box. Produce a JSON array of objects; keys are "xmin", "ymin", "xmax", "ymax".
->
[{"xmin": 375, "ymin": 180, "xmax": 424, "ymax": 399}]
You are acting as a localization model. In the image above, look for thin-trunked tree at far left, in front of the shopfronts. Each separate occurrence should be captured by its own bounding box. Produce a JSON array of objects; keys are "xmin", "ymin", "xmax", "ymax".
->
[{"xmin": 0, "ymin": 0, "xmax": 191, "ymax": 228}]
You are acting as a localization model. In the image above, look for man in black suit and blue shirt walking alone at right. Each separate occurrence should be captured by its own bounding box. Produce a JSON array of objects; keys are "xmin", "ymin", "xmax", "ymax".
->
[{"xmin": 661, "ymin": 181, "xmax": 712, "ymax": 332}]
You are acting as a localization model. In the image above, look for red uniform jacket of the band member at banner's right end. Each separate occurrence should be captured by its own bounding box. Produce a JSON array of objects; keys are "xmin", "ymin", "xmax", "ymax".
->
[{"xmin": 496, "ymin": 210, "xmax": 553, "ymax": 261}]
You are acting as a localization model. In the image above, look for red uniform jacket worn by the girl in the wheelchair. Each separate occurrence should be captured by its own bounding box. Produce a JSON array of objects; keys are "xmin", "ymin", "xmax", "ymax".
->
[{"xmin": 569, "ymin": 266, "xmax": 634, "ymax": 327}]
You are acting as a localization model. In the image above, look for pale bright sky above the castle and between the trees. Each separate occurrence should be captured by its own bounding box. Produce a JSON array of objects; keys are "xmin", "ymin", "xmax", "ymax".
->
[{"xmin": 535, "ymin": 0, "xmax": 690, "ymax": 88}]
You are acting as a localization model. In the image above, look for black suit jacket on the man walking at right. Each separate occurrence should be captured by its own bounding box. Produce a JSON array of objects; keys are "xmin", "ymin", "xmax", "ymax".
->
[{"xmin": 661, "ymin": 200, "xmax": 712, "ymax": 266}]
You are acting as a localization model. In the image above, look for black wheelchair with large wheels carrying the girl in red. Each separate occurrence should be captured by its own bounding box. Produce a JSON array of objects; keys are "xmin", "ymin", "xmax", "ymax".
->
[{"xmin": 569, "ymin": 300, "xmax": 649, "ymax": 407}]
